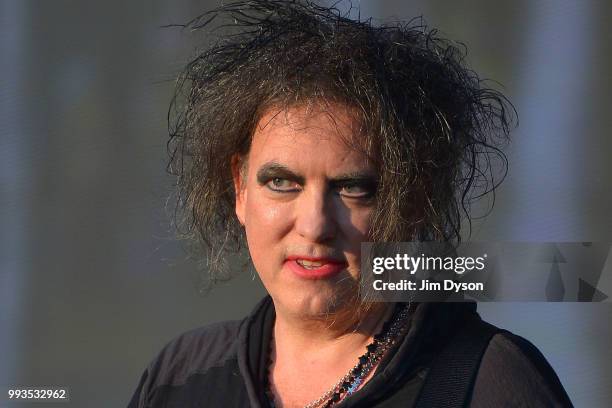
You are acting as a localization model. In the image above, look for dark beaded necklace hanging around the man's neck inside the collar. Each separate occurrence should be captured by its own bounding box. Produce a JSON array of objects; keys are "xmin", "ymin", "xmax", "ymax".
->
[{"xmin": 264, "ymin": 303, "xmax": 411, "ymax": 408}]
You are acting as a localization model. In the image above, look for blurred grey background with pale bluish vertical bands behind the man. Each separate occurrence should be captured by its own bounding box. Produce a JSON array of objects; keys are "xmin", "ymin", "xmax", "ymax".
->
[{"xmin": 0, "ymin": 0, "xmax": 612, "ymax": 407}]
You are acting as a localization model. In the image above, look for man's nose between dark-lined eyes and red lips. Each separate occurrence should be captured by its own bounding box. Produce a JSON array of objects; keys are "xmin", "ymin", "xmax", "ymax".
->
[{"xmin": 295, "ymin": 188, "xmax": 337, "ymax": 243}]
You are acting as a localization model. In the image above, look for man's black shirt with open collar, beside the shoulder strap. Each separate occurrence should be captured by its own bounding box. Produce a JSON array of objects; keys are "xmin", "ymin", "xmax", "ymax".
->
[{"xmin": 129, "ymin": 297, "xmax": 571, "ymax": 408}]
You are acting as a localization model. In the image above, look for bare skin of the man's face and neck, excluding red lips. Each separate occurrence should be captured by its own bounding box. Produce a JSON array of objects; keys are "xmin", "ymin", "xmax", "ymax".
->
[{"xmin": 232, "ymin": 104, "xmax": 390, "ymax": 407}]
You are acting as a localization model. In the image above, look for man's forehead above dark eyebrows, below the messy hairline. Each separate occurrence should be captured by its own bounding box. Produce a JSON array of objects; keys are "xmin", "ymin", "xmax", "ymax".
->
[{"xmin": 249, "ymin": 105, "xmax": 369, "ymax": 166}]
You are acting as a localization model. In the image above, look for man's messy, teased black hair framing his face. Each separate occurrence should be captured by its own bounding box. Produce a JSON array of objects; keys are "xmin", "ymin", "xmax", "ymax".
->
[{"xmin": 169, "ymin": 0, "xmax": 515, "ymax": 281}]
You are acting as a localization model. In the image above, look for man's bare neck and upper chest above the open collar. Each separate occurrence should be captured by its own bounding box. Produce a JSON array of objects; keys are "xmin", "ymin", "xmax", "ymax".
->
[{"xmin": 268, "ymin": 303, "xmax": 394, "ymax": 407}]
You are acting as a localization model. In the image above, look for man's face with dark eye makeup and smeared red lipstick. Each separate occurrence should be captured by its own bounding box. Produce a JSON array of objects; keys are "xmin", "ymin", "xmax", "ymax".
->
[{"xmin": 233, "ymin": 105, "xmax": 377, "ymax": 317}]
